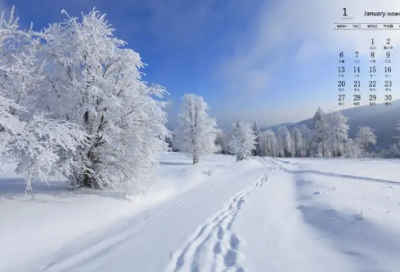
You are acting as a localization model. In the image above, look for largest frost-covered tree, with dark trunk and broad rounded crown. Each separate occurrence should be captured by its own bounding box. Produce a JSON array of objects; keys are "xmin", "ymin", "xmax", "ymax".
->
[{"xmin": 32, "ymin": 10, "xmax": 169, "ymax": 192}]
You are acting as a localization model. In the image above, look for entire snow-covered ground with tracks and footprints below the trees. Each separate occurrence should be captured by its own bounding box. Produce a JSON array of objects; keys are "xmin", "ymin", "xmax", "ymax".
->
[{"xmin": 0, "ymin": 153, "xmax": 400, "ymax": 272}]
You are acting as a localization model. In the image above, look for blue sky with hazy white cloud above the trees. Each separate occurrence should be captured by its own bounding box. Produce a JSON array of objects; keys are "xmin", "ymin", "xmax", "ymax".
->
[{"xmin": 0, "ymin": 0, "xmax": 400, "ymax": 128}]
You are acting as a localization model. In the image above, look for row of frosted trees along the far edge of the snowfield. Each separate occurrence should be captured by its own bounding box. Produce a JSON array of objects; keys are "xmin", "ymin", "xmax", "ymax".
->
[{"xmin": 172, "ymin": 98, "xmax": 384, "ymax": 163}]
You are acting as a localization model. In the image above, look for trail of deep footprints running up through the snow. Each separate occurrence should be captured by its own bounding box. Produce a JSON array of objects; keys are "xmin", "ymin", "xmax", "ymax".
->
[{"xmin": 166, "ymin": 167, "xmax": 273, "ymax": 272}]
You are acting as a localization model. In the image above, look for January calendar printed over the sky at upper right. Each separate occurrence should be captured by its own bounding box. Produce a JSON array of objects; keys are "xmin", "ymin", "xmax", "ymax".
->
[{"xmin": 334, "ymin": 8, "xmax": 400, "ymax": 106}]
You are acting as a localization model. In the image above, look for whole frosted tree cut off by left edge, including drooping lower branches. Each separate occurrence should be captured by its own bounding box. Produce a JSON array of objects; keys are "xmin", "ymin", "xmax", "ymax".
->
[{"xmin": 0, "ymin": 8, "xmax": 87, "ymax": 190}]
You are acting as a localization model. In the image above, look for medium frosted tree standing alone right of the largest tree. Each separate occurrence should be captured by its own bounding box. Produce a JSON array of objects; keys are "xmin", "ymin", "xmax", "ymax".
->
[{"xmin": 174, "ymin": 94, "xmax": 218, "ymax": 164}]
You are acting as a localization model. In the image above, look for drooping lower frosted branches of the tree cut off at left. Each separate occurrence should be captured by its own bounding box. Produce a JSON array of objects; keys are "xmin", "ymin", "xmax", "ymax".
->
[{"xmin": 8, "ymin": 115, "xmax": 87, "ymax": 190}]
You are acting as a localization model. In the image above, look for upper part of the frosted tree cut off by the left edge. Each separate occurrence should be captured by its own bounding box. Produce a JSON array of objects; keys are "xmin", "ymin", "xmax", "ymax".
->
[{"xmin": 0, "ymin": 8, "xmax": 42, "ymax": 139}]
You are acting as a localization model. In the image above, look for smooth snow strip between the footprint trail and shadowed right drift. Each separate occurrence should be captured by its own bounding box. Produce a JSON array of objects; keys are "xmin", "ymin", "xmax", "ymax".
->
[{"xmin": 234, "ymin": 171, "xmax": 355, "ymax": 272}]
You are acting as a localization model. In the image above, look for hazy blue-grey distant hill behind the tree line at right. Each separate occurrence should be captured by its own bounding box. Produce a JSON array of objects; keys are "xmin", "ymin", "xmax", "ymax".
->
[{"xmin": 268, "ymin": 100, "xmax": 400, "ymax": 149}]
